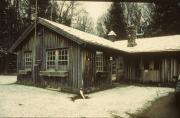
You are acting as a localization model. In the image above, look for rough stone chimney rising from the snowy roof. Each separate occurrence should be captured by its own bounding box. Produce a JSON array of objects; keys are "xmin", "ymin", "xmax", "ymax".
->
[{"xmin": 127, "ymin": 25, "xmax": 137, "ymax": 47}]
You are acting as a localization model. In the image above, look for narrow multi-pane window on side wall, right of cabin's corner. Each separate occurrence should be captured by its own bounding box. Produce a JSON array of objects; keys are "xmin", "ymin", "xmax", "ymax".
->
[{"xmin": 96, "ymin": 52, "xmax": 104, "ymax": 72}]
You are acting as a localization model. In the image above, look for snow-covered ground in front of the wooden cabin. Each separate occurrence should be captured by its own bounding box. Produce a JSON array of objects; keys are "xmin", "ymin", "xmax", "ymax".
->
[{"xmin": 0, "ymin": 76, "xmax": 174, "ymax": 117}]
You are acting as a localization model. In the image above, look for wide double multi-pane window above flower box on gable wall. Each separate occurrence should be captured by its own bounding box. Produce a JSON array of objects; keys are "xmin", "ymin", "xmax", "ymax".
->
[{"xmin": 47, "ymin": 49, "xmax": 69, "ymax": 71}]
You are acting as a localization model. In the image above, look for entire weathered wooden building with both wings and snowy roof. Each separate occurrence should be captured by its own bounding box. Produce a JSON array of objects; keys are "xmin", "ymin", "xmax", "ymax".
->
[{"xmin": 10, "ymin": 18, "xmax": 180, "ymax": 91}]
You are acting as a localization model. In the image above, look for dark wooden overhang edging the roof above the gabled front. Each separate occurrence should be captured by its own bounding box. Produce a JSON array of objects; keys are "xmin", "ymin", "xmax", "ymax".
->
[{"xmin": 9, "ymin": 18, "xmax": 124, "ymax": 52}]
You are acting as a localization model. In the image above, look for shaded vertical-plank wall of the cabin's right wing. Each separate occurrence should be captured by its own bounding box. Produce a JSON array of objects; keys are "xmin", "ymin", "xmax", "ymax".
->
[{"xmin": 125, "ymin": 53, "xmax": 180, "ymax": 83}]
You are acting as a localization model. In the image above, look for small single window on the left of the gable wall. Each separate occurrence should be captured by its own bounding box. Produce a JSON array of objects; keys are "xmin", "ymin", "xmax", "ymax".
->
[{"xmin": 24, "ymin": 52, "xmax": 32, "ymax": 68}]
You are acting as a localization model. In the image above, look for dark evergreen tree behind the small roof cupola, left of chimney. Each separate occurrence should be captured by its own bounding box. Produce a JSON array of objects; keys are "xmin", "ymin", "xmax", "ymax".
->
[{"xmin": 104, "ymin": 2, "xmax": 127, "ymax": 40}]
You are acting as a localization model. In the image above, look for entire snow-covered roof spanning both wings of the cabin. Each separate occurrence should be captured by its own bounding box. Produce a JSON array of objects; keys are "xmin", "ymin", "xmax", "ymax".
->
[{"xmin": 9, "ymin": 18, "xmax": 180, "ymax": 53}]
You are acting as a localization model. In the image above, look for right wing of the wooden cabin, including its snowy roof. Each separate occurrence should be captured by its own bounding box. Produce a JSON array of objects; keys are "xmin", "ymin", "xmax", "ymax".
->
[{"xmin": 115, "ymin": 35, "xmax": 180, "ymax": 84}]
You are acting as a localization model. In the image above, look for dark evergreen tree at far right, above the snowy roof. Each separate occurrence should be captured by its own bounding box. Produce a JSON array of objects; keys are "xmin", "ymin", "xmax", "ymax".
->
[{"xmin": 145, "ymin": 1, "xmax": 180, "ymax": 36}]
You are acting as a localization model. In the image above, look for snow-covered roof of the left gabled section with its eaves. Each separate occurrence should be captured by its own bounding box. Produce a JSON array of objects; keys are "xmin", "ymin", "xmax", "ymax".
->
[{"xmin": 10, "ymin": 18, "xmax": 120, "ymax": 51}]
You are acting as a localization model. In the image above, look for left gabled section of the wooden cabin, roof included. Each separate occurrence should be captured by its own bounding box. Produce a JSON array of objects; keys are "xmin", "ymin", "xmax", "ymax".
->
[{"xmin": 10, "ymin": 18, "xmax": 124, "ymax": 91}]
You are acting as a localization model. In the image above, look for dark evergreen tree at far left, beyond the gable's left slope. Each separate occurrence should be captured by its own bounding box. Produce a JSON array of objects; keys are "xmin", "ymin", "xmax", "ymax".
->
[{"xmin": 0, "ymin": 0, "xmax": 24, "ymax": 49}]
